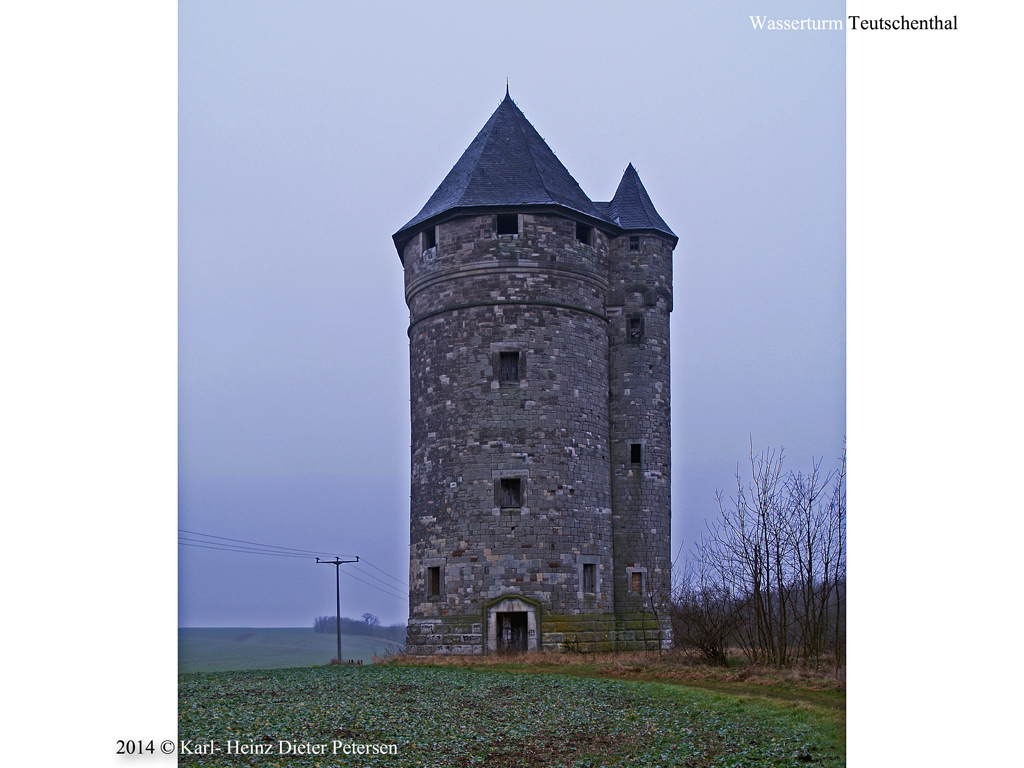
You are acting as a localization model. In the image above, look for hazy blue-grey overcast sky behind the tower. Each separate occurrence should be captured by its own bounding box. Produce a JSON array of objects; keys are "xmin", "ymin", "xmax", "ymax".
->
[{"xmin": 178, "ymin": 1, "xmax": 846, "ymax": 627}]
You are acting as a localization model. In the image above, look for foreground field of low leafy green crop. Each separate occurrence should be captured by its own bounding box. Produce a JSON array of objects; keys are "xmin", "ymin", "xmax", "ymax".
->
[{"xmin": 178, "ymin": 666, "xmax": 845, "ymax": 768}]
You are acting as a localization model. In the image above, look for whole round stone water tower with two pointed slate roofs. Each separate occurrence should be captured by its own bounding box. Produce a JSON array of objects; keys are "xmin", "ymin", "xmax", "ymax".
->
[{"xmin": 394, "ymin": 93, "xmax": 678, "ymax": 653}]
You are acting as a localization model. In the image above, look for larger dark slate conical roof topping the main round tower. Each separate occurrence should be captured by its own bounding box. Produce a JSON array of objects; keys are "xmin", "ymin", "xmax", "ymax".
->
[{"xmin": 393, "ymin": 91, "xmax": 606, "ymax": 254}]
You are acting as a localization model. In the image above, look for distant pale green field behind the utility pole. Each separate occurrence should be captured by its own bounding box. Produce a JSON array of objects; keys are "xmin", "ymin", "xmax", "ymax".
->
[{"xmin": 178, "ymin": 628, "xmax": 398, "ymax": 672}]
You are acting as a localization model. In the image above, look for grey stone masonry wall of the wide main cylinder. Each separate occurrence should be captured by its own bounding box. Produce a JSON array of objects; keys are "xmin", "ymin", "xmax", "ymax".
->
[{"xmin": 404, "ymin": 214, "xmax": 613, "ymax": 653}]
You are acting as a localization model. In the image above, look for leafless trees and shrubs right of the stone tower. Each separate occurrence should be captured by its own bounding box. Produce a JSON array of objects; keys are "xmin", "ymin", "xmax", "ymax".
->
[{"xmin": 674, "ymin": 444, "xmax": 846, "ymax": 666}]
